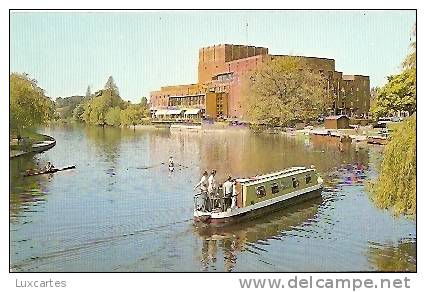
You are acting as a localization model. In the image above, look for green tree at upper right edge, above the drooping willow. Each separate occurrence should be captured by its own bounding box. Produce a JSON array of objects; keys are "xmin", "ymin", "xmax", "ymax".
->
[{"xmin": 370, "ymin": 26, "xmax": 417, "ymax": 118}]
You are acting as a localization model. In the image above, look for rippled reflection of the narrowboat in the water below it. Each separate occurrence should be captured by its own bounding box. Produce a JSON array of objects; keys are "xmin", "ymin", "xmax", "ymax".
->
[{"xmin": 194, "ymin": 197, "xmax": 323, "ymax": 272}]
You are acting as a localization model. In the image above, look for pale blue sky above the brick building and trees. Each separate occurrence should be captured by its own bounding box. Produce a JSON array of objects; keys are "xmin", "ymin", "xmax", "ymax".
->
[{"xmin": 10, "ymin": 11, "xmax": 416, "ymax": 101}]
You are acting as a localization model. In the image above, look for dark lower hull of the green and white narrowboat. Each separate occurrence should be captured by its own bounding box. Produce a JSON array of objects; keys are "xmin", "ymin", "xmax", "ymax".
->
[{"xmin": 194, "ymin": 187, "xmax": 322, "ymax": 227}]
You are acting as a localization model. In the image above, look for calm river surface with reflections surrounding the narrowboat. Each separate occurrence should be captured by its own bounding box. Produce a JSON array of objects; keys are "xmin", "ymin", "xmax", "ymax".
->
[{"xmin": 10, "ymin": 125, "xmax": 416, "ymax": 272}]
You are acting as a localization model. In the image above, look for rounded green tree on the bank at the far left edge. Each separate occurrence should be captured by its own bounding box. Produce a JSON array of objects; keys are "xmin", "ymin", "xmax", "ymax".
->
[{"xmin": 9, "ymin": 73, "xmax": 54, "ymax": 133}]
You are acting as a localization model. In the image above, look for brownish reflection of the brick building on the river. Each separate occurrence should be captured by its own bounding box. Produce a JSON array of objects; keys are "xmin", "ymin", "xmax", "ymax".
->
[{"xmin": 196, "ymin": 131, "xmax": 369, "ymax": 184}]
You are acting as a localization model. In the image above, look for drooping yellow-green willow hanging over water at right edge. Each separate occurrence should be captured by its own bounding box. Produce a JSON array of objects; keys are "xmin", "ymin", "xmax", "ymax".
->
[{"xmin": 370, "ymin": 116, "xmax": 417, "ymax": 217}]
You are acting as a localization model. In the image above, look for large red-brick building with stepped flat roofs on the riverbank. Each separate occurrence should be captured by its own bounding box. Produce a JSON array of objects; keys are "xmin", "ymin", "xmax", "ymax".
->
[{"xmin": 150, "ymin": 44, "xmax": 370, "ymax": 120}]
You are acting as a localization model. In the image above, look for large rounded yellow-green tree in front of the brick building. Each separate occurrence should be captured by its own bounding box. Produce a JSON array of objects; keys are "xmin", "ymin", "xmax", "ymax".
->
[{"xmin": 244, "ymin": 57, "xmax": 330, "ymax": 126}]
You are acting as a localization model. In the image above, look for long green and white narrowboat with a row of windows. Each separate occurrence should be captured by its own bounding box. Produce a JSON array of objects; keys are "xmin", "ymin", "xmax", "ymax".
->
[{"xmin": 194, "ymin": 167, "xmax": 323, "ymax": 226}]
